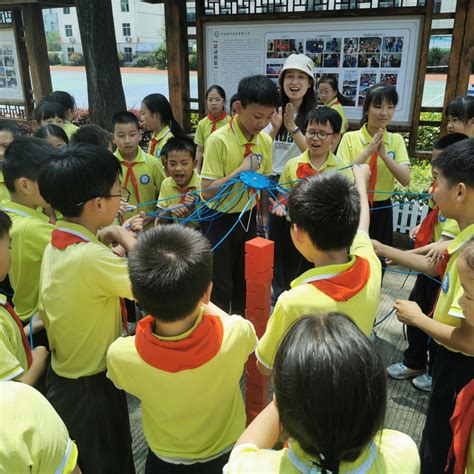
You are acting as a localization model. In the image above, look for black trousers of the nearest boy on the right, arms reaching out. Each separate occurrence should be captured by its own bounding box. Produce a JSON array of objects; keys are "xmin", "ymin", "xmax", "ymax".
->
[{"xmin": 420, "ymin": 340, "xmax": 474, "ymax": 474}]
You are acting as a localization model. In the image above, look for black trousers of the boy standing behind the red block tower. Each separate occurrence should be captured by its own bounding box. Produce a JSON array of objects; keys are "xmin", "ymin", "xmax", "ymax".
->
[{"xmin": 203, "ymin": 209, "xmax": 257, "ymax": 317}]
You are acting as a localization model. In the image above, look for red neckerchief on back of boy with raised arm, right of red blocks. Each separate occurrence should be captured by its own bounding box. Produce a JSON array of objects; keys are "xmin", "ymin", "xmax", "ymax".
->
[{"xmin": 308, "ymin": 256, "xmax": 370, "ymax": 302}]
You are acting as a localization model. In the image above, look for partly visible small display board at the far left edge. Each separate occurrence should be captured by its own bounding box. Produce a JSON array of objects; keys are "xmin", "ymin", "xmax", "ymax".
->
[{"xmin": 0, "ymin": 28, "xmax": 24, "ymax": 101}]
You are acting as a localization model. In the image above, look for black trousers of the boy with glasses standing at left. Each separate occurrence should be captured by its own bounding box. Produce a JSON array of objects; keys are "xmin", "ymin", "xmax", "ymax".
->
[{"xmin": 46, "ymin": 367, "xmax": 135, "ymax": 474}]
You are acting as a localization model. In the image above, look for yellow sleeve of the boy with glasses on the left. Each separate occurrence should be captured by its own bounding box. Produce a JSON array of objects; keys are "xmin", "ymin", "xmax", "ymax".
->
[{"xmin": 82, "ymin": 244, "xmax": 133, "ymax": 300}]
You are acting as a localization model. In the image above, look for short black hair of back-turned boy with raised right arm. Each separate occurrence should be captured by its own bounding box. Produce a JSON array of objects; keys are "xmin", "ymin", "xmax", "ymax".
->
[{"xmin": 288, "ymin": 172, "xmax": 360, "ymax": 251}]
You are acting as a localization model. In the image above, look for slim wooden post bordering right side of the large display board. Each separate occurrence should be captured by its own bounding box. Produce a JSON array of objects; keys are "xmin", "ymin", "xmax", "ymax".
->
[{"xmin": 408, "ymin": 0, "xmax": 433, "ymax": 154}]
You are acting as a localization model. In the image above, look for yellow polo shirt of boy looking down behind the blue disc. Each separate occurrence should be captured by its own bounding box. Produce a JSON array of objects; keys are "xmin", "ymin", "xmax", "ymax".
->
[{"xmin": 201, "ymin": 116, "xmax": 272, "ymax": 214}]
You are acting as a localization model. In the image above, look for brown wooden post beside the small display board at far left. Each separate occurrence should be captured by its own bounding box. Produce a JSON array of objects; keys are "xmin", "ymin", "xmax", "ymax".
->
[{"xmin": 21, "ymin": 4, "xmax": 53, "ymax": 103}]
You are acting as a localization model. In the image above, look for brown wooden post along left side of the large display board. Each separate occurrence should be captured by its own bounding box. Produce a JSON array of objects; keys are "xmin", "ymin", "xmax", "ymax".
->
[{"xmin": 165, "ymin": 0, "xmax": 191, "ymax": 132}]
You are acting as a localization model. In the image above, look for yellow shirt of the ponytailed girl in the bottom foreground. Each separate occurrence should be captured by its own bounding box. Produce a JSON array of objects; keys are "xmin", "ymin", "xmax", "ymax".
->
[{"xmin": 223, "ymin": 430, "xmax": 420, "ymax": 474}]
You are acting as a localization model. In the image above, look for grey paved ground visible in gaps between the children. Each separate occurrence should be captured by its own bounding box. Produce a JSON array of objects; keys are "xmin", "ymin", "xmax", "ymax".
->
[{"xmin": 129, "ymin": 267, "xmax": 428, "ymax": 474}]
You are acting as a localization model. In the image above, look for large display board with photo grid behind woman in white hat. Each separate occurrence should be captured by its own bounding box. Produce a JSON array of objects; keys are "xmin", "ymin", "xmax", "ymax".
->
[{"xmin": 204, "ymin": 17, "xmax": 421, "ymax": 125}]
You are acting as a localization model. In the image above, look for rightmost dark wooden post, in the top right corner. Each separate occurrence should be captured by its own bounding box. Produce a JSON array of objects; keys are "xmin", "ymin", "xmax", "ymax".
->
[{"xmin": 441, "ymin": 0, "xmax": 472, "ymax": 136}]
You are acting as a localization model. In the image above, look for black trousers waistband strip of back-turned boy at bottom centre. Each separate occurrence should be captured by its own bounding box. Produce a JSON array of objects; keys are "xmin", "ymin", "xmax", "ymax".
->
[{"xmin": 145, "ymin": 449, "xmax": 230, "ymax": 474}]
